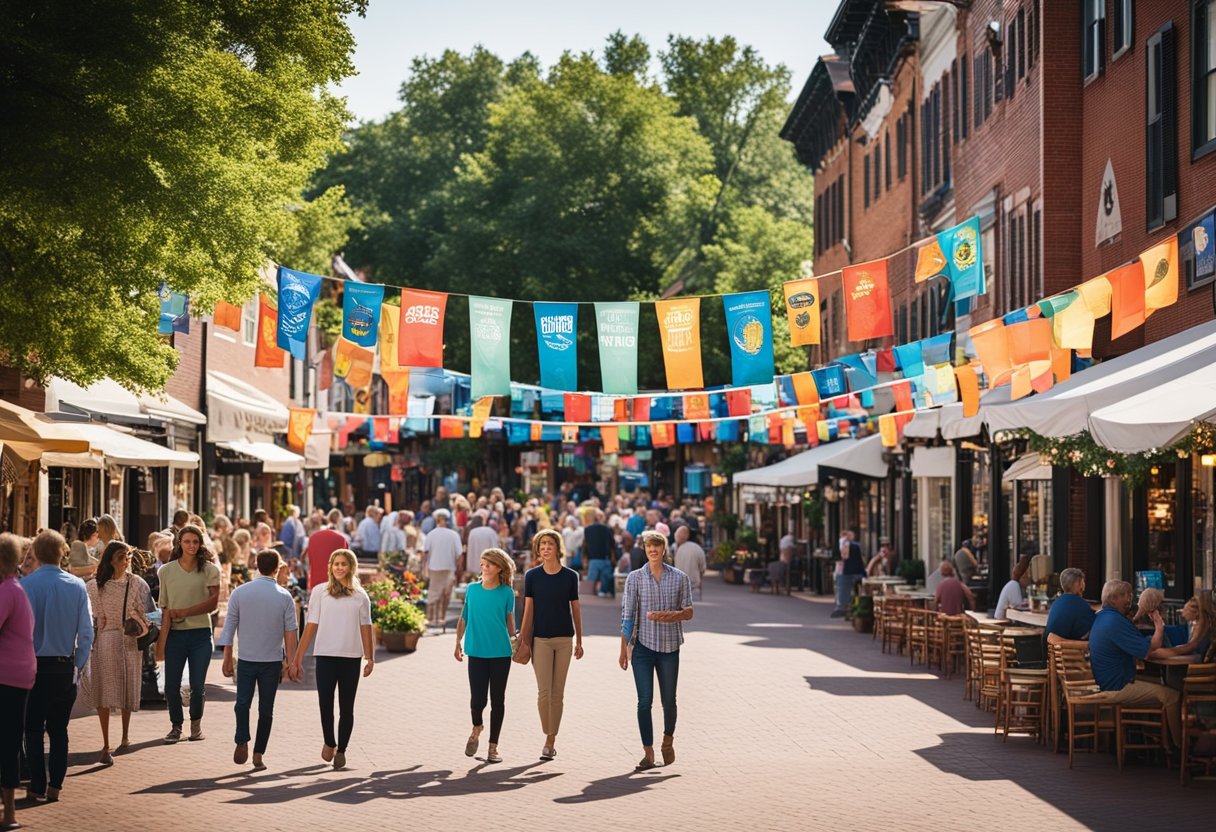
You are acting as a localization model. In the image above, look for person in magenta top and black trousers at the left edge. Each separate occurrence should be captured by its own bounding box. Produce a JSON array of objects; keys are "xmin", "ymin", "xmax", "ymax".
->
[{"xmin": 0, "ymin": 534, "xmax": 38, "ymax": 830}]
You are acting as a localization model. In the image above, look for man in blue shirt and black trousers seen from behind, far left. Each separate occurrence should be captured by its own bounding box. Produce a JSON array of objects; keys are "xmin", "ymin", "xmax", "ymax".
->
[{"xmin": 21, "ymin": 530, "xmax": 92, "ymax": 802}]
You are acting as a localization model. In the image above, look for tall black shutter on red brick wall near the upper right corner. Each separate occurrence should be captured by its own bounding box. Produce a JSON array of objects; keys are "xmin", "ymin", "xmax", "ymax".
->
[{"xmin": 1144, "ymin": 22, "xmax": 1178, "ymax": 230}]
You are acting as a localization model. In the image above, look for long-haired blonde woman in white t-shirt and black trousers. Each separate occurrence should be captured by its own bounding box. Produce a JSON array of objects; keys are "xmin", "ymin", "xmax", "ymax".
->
[{"xmin": 292, "ymin": 549, "xmax": 376, "ymax": 769}]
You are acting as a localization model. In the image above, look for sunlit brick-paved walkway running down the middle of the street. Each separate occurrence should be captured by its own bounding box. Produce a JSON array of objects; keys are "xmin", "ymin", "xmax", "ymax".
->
[{"xmin": 18, "ymin": 578, "xmax": 1216, "ymax": 832}]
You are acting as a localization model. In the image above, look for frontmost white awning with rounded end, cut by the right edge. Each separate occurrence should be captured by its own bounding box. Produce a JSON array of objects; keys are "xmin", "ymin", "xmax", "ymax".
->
[{"xmin": 1090, "ymin": 364, "xmax": 1216, "ymax": 454}]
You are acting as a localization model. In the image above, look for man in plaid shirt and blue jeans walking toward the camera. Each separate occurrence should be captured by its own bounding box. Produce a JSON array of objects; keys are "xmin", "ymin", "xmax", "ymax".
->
[{"xmin": 620, "ymin": 532, "xmax": 693, "ymax": 771}]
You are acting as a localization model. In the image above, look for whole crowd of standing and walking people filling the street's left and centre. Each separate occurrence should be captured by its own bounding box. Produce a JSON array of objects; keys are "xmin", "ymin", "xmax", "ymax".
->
[{"xmin": 0, "ymin": 488, "xmax": 705, "ymax": 828}]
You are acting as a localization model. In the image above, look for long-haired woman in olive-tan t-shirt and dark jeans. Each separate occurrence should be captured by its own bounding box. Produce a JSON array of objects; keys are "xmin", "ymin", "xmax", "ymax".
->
[{"xmin": 157, "ymin": 523, "xmax": 220, "ymax": 744}]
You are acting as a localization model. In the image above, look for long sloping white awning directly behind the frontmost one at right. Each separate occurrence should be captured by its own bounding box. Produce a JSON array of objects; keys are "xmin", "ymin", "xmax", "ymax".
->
[{"xmin": 980, "ymin": 320, "xmax": 1216, "ymax": 437}]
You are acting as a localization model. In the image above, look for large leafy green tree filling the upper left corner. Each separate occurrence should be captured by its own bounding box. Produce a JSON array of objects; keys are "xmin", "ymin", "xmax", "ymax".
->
[{"xmin": 0, "ymin": 0, "xmax": 366, "ymax": 388}]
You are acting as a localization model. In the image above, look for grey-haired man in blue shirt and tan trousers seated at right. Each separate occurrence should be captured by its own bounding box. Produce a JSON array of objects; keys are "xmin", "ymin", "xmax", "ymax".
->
[{"xmin": 1090, "ymin": 580, "xmax": 1182, "ymax": 747}]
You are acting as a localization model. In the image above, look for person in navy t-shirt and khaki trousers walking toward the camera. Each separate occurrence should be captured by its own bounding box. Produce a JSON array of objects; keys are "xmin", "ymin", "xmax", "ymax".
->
[{"xmin": 514, "ymin": 529, "xmax": 582, "ymax": 760}]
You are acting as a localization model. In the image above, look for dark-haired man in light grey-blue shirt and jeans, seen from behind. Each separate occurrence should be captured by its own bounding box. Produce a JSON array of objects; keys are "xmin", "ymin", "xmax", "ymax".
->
[{"xmin": 219, "ymin": 550, "xmax": 298, "ymax": 771}]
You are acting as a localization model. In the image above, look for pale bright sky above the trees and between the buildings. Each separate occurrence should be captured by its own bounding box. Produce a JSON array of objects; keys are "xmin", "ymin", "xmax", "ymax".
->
[{"xmin": 338, "ymin": 0, "xmax": 837, "ymax": 120}]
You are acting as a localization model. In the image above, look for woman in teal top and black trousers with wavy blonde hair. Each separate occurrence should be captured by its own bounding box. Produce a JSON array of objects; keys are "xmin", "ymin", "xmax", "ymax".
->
[{"xmin": 456, "ymin": 549, "xmax": 516, "ymax": 763}]
